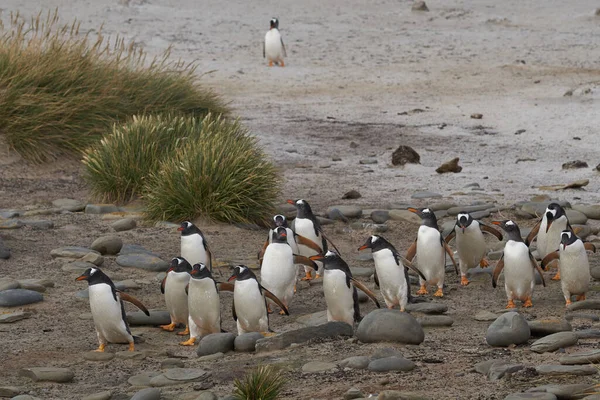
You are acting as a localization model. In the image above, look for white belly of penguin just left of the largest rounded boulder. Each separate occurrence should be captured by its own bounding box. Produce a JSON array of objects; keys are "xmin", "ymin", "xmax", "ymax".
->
[{"xmin": 323, "ymin": 269, "xmax": 354, "ymax": 326}]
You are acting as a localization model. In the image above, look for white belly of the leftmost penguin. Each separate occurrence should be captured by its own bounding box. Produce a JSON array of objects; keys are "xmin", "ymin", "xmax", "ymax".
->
[{"xmin": 89, "ymin": 283, "xmax": 133, "ymax": 343}]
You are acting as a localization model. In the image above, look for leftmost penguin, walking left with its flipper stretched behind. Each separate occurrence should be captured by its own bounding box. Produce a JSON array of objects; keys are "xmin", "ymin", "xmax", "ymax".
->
[{"xmin": 76, "ymin": 268, "xmax": 150, "ymax": 352}]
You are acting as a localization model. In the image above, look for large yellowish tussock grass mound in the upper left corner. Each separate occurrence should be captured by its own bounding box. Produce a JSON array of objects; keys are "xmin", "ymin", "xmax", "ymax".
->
[{"xmin": 0, "ymin": 11, "xmax": 227, "ymax": 162}]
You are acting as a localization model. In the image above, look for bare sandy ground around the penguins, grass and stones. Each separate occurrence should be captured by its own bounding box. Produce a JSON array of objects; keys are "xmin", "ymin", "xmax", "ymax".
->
[{"xmin": 0, "ymin": 0, "xmax": 600, "ymax": 399}]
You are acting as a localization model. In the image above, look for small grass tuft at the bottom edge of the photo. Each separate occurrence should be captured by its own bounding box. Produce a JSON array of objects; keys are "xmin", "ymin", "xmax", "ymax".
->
[{"xmin": 234, "ymin": 365, "xmax": 285, "ymax": 400}]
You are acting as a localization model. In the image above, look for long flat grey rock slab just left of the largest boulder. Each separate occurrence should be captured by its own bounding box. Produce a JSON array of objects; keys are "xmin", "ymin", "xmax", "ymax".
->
[{"xmin": 256, "ymin": 321, "xmax": 356, "ymax": 353}]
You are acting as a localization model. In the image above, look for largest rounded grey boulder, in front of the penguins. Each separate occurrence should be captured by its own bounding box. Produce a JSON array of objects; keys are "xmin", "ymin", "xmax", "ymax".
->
[{"xmin": 356, "ymin": 309, "xmax": 425, "ymax": 344}]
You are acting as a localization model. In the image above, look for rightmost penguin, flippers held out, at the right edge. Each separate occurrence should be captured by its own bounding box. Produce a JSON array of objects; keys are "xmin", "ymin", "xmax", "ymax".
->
[{"xmin": 542, "ymin": 229, "xmax": 596, "ymax": 305}]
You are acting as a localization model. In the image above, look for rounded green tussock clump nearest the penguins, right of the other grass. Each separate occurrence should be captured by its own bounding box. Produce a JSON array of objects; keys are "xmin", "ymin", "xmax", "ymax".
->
[{"xmin": 143, "ymin": 115, "xmax": 280, "ymax": 223}]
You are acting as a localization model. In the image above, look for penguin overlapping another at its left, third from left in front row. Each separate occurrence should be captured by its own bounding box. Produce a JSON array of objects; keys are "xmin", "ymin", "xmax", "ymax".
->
[{"xmin": 180, "ymin": 264, "xmax": 221, "ymax": 346}]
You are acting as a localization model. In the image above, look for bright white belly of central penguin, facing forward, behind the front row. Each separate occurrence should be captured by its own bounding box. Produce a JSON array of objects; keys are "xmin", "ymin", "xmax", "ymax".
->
[{"xmin": 260, "ymin": 243, "xmax": 297, "ymax": 306}]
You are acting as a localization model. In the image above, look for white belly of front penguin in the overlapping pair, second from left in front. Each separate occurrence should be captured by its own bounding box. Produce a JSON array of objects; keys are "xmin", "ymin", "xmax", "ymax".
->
[{"xmin": 188, "ymin": 278, "xmax": 221, "ymax": 334}]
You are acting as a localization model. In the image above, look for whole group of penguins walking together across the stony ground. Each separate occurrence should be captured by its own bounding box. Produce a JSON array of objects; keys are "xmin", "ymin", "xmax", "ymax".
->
[{"xmin": 77, "ymin": 199, "xmax": 595, "ymax": 351}]
